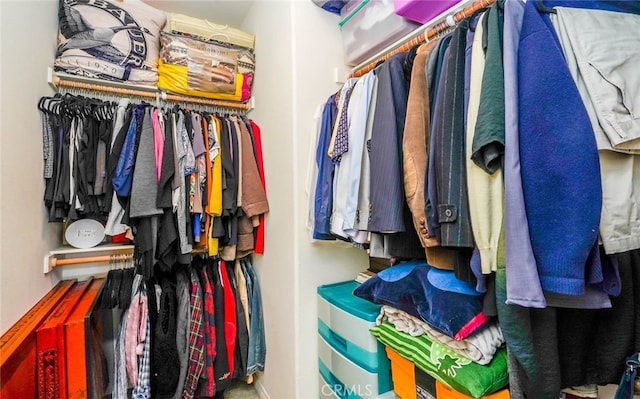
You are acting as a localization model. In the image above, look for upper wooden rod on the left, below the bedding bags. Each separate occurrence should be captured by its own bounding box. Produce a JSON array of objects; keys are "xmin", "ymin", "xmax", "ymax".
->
[{"xmin": 52, "ymin": 76, "xmax": 251, "ymax": 111}]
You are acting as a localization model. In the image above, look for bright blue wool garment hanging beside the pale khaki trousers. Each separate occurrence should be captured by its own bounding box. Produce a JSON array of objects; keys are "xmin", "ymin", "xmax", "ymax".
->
[{"xmin": 518, "ymin": 1, "xmax": 602, "ymax": 295}]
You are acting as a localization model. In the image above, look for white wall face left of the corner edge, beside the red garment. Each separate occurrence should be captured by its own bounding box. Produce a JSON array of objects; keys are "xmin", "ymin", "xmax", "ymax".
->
[{"xmin": 243, "ymin": 1, "xmax": 297, "ymax": 399}]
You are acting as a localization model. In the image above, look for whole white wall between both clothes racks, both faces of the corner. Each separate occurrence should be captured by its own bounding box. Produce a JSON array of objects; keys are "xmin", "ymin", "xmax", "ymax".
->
[{"xmin": 243, "ymin": 0, "xmax": 367, "ymax": 399}]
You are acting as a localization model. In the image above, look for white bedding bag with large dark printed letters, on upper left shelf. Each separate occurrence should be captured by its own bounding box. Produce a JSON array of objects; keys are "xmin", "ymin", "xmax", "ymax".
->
[{"xmin": 54, "ymin": 0, "xmax": 166, "ymax": 86}]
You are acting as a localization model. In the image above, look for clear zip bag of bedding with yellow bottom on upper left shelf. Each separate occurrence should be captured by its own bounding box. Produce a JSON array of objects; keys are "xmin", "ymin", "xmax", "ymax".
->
[{"xmin": 158, "ymin": 32, "xmax": 250, "ymax": 101}]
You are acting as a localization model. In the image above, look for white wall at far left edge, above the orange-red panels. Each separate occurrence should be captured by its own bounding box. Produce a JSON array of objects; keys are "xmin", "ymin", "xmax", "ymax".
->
[{"xmin": 0, "ymin": 0, "xmax": 60, "ymax": 333}]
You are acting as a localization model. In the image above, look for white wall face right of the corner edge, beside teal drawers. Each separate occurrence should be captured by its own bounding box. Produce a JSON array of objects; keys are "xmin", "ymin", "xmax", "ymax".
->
[{"xmin": 293, "ymin": 1, "xmax": 368, "ymax": 399}]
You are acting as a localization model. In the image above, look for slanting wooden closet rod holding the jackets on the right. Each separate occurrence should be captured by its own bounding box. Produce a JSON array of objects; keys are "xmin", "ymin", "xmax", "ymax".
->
[{"xmin": 349, "ymin": 0, "xmax": 496, "ymax": 78}]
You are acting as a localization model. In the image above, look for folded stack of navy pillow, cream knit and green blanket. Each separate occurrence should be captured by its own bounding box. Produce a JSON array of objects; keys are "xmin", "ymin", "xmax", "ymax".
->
[{"xmin": 354, "ymin": 261, "xmax": 509, "ymax": 399}]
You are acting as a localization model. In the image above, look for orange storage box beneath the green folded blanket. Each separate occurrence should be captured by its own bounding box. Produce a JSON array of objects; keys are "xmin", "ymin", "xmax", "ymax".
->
[{"xmin": 385, "ymin": 347, "xmax": 510, "ymax": 399}]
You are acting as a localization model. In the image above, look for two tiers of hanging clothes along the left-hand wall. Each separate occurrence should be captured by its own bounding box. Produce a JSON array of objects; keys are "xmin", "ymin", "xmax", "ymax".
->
[{"xmin": 38, "ymin": 85, "xmax": 269, "ymax": 399}]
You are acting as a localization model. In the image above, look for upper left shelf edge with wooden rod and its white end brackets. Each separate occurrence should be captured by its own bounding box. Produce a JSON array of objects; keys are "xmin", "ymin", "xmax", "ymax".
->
[{"xmin": 47, "ymin": 67, "xmax": 255, "ymax": 111}]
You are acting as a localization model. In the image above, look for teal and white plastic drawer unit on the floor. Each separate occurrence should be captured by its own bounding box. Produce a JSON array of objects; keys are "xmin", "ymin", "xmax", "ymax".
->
[{"xmin": 318, "ymin": 281, "xmax": 393, "ymax": 399}]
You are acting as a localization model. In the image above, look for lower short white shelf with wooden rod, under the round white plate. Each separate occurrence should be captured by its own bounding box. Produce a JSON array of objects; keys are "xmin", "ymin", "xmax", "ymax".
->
[{"xmin": 43, "ymin": 244, "xmax": 134, "ymax": 274}]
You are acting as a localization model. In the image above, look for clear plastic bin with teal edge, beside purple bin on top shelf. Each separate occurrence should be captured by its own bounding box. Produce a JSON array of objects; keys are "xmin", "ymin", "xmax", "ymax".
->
[{"xmin": 339, "ymin": 0, "xmax": 420, "ymax": 65}]
